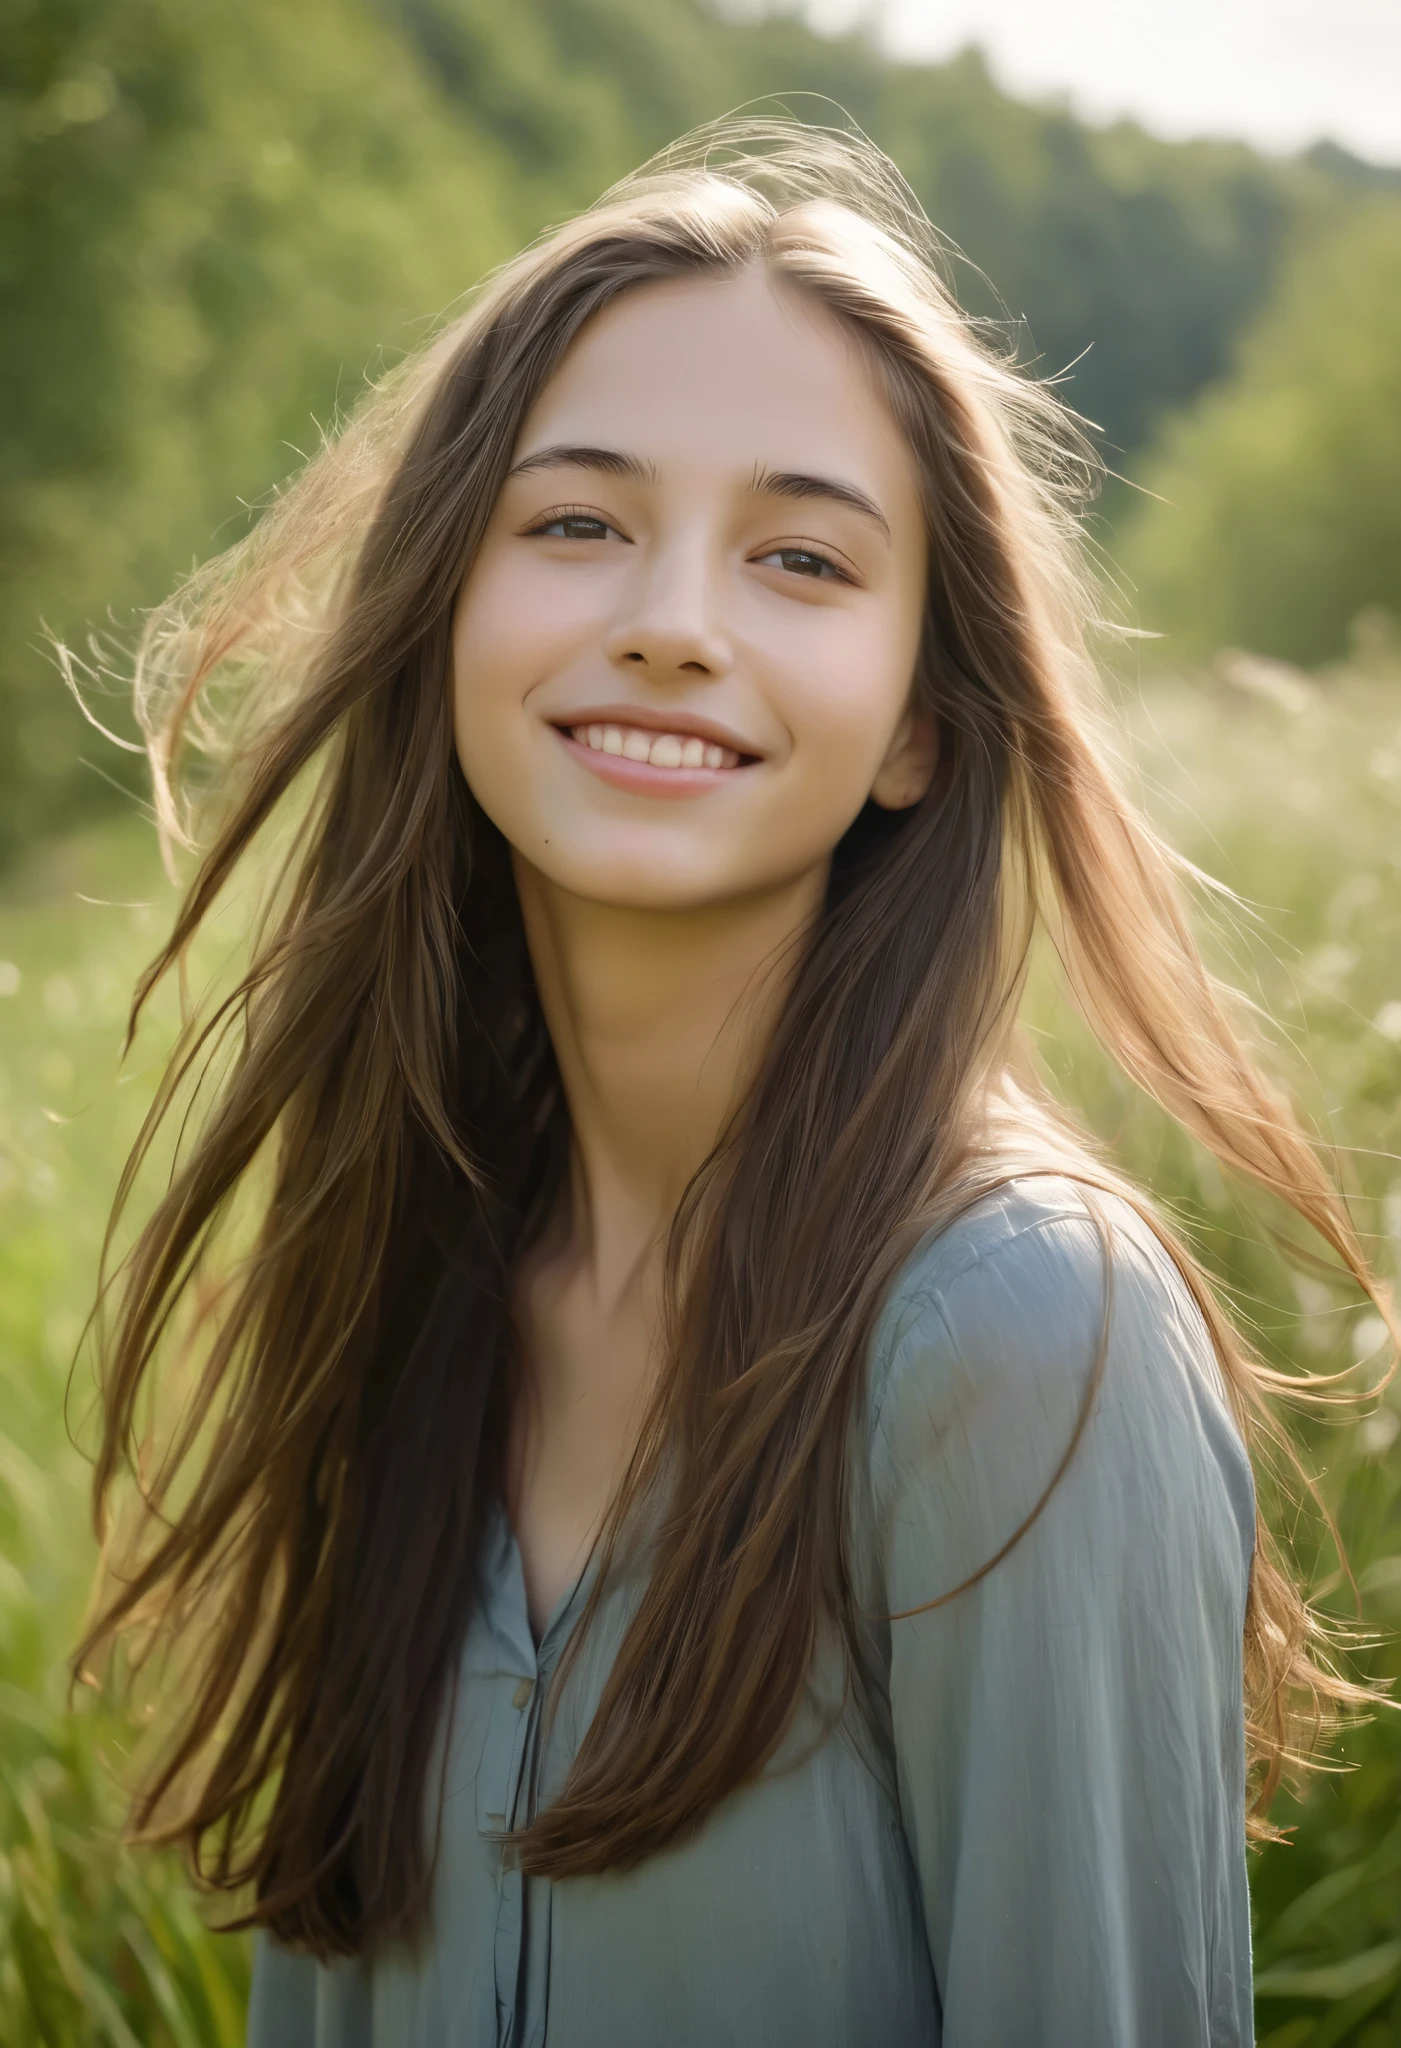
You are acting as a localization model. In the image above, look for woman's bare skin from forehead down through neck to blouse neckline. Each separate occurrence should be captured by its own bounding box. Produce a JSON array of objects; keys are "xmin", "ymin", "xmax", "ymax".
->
[{"xmin": 455, "ymin": 272, "xmax": 934, "ymax": 1634}]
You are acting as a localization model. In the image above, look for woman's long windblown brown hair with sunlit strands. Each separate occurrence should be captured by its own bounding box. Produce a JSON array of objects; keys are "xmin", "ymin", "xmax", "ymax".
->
[{"xmin": 80, "ymin": 121, "xmax": 1372, "ymax": 1956}]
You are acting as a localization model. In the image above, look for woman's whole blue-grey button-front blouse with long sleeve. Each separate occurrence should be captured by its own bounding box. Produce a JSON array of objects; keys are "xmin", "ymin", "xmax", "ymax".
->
[{"xmin": 248, "ymin": 1178, "xmax": 1254, "ymax": 2048}]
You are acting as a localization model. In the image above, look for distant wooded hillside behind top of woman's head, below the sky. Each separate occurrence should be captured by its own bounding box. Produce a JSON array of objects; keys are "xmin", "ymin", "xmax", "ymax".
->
[{"xmin": 383, "ymin": 0, "xmax": 1327, "ymax": 449}]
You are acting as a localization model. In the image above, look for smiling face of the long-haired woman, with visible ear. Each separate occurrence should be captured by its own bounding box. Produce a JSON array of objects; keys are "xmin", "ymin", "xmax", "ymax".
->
[{"xmin": 453, "ymin": 270, "xmax": 932, "ymax": 909}]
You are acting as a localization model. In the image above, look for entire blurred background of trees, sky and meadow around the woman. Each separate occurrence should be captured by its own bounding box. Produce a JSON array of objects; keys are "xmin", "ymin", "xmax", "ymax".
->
[{"xmin": 0, "ymin": 0, "xmax": 1401, "ymax": 2048}]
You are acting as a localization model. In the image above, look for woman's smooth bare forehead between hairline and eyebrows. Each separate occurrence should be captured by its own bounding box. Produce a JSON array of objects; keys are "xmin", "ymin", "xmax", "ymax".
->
[{"xmin": 518, "ymin": 268, "xmax": 918, "ymax": 514}]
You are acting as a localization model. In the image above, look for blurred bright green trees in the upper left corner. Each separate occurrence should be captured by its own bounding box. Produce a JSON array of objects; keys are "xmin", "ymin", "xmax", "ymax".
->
[{"xmin": 0, "ymin": 0, "xmax": 516, "ymax": 854}]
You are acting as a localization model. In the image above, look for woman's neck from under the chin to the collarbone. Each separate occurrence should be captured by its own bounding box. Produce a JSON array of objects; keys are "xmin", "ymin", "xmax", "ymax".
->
[{"xmin": 516, "ymin": 860, "xmax": 825, "ymax": 1300}]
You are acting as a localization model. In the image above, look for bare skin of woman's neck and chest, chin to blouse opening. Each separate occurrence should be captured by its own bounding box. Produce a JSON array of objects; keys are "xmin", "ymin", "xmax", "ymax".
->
[{"xmin": 508, "ymin": 868, "xmax": 815, "ymax": 1634}]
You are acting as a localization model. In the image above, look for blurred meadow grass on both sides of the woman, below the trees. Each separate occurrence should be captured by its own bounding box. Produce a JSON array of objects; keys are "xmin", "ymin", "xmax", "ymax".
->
[{"xmin": 0, "ymin": 655, "xmax": 1401, "ymax": 2048}]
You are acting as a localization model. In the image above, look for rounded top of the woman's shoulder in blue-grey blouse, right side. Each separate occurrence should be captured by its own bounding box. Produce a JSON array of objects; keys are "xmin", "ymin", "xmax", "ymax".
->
[{"xmin": 866, "ymin": 1174, "xmax": 1254, "ymax": 1542}]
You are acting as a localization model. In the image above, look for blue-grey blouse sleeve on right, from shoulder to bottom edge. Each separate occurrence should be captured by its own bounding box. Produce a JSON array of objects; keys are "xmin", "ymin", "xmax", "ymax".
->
[{"xmin": 873, "ymin": 1182, "xmax": 1254, "ymax": 2048}]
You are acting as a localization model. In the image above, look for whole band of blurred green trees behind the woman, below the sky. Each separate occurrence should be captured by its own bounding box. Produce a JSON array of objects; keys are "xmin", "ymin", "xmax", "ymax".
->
[{"xmin": 0, "ymin": 0, "xmax": 1401, "ymax": 858}]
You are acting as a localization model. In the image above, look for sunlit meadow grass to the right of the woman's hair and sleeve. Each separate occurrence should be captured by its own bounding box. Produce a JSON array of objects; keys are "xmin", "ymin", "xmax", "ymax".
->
[{"xmin": 1036, "ymin": 659, "xmax": 1401, "ymax": 2048}]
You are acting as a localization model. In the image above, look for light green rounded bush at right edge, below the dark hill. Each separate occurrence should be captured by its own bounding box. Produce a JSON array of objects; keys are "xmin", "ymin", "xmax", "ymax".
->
[{"xmin": 1120, "ymin": 199, "xmax": 1401, "ymax": 662}]
